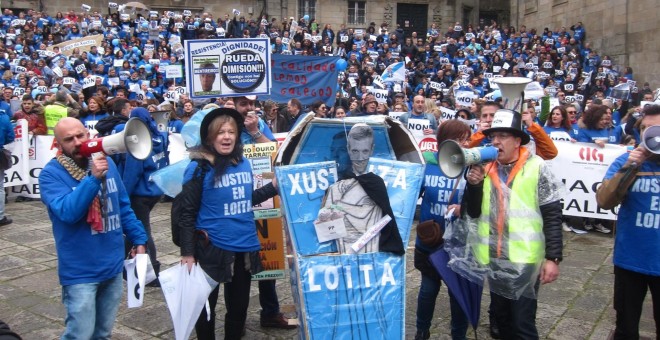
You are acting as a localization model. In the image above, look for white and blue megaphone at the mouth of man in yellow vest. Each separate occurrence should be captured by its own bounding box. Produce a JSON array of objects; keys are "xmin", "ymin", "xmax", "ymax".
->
[{"xmin": 438, "ymin": 140, "xmax": 497, "ymax": 178}]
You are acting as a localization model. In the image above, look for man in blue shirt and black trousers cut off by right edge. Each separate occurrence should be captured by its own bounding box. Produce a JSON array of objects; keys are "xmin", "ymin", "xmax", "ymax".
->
[{"xmin": 596, "ymin": 105, "xmax": 660, "ymax": 339}]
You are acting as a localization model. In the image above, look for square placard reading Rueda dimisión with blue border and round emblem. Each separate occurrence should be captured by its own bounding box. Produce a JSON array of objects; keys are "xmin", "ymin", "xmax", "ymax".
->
[{"xmin": 185, "ymin": 39, "xmax": 271, "ymax": 99}]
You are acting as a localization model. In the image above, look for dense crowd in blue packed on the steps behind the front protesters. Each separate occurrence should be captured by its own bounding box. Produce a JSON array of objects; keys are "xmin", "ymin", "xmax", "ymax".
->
[{"xmin": 0, "ymin": 8, "xmax": 653, "ymax": 143}]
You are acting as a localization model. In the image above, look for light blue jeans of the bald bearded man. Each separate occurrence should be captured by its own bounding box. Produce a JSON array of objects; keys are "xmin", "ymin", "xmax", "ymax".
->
[{"xmin": 62, "ymin": 273, "xmax": 123, "ymax": 340}]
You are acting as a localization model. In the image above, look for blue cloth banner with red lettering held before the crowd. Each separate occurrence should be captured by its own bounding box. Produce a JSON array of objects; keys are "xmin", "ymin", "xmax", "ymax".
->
[{"xmin": 260, "ymin": 54, "xmax": 339, "ymax": 106}]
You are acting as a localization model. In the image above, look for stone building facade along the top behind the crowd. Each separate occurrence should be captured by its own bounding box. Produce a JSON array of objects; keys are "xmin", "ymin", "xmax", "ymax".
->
[{"xmin": 7, "ymin": 0, "xmax": 660, "ymax": 88}]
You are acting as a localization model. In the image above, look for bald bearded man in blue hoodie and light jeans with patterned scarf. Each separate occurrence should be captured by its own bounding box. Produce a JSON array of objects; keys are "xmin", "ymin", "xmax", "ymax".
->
[{"xmin": 39, "ymin": 117, "xmax": 147, "ymax": 339}]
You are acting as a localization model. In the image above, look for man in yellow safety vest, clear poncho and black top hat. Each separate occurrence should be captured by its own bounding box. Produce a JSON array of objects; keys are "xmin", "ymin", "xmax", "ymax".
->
[{"xmin": 461, "ymin": 109, "xmax": 563, "ymax": 339}]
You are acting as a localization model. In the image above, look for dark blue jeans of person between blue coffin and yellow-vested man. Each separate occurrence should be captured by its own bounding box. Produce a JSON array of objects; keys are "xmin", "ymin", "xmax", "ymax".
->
[{"xmin": 416, "ymin": 274, "xmax": 468, "ymax": 340}]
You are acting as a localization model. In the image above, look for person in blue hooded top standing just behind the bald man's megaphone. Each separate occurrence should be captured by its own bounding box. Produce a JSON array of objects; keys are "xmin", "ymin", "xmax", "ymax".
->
[{"xmin": 122, "ymin": 107, "xmax": 167, "ymax": 286}]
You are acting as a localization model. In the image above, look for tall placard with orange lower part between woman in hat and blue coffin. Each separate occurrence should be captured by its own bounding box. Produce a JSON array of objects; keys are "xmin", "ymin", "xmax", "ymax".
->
[{"xmin": 243, "ymin": 142, "xmax": 285, "ymax": 280}]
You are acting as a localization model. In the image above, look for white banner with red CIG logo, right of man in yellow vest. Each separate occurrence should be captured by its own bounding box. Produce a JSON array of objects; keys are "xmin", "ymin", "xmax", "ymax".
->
[{"xmin": 546, "ymin": 141, "xmax": 626, "ymax": 220}]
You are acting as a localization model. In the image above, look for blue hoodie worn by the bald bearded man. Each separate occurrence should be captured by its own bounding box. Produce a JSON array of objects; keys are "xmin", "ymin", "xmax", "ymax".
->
[{"xmin": 39, "ymin": 158, "xmax": 147, "ymax": 286}]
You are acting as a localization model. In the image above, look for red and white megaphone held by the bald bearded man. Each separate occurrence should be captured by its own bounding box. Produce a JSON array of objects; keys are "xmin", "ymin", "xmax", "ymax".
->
[{"xmin": 80, "ymin": 118, "xmax": 152, "ymax": 160}]
